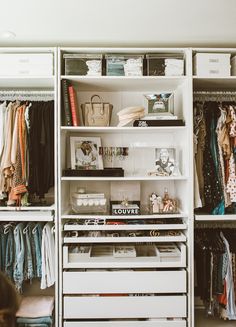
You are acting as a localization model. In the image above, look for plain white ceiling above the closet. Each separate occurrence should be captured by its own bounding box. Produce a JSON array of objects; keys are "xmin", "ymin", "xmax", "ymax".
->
[{"xmin": 0, "ymin": 0, "xmax": 236, "ymax": 47}]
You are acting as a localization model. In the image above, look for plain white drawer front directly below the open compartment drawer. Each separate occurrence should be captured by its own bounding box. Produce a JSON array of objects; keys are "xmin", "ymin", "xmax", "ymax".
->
[{"xmin": 63, "ymin": 270, "xmax": 186, "ymax": 294}]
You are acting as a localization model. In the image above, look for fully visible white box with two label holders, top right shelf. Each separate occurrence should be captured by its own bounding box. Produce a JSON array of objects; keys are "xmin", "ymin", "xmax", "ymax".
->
[{"xmin": 193, "ymin": 53, "xmax": 231, "ymax": 77}]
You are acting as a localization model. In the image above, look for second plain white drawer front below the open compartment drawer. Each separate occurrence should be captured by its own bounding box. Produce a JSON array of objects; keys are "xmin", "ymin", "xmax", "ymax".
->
[{"xmin": 64, "ymin": 295, "xmax": 186, "ymax": 319}]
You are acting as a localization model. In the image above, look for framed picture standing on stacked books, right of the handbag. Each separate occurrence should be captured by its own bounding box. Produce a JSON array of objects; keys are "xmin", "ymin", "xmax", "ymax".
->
[{"xmin": 145, "ymin": 93, "xmax": 174, "ymax": 116}]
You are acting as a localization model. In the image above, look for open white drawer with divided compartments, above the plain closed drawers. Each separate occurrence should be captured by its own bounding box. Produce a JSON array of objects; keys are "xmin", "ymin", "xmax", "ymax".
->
[{"xmin": 63, "ymin": 243, "xmax": 186, "ymax": 268}]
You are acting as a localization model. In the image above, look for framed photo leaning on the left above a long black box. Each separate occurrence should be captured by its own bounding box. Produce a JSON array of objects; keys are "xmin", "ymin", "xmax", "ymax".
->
[{"xmin": 70, "ymin": 136, "xmax": 103, "ymax": 169}]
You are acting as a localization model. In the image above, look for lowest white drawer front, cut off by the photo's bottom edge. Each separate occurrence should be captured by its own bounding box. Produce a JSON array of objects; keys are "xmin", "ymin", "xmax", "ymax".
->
[{"xmin": 64, "ymin": 320, "xmax": 187, "ymax": 327}]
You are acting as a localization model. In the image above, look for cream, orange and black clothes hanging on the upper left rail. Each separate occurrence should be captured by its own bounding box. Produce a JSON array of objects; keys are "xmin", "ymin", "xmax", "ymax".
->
[{"xmin": 0, "ymin": 101, "xmax": 54, "ymax": 205}]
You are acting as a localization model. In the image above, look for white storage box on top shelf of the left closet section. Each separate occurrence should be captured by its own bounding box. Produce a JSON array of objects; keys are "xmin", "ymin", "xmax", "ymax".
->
[{"xmin": 0, "ymin": 53, "xmax": 53, "ymax": 76}]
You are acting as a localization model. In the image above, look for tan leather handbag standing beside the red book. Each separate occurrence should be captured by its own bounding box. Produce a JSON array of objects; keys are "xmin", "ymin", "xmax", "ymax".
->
[{"xmin": 81, "ymin": 94, "xmax": 113, "ymax": 127}]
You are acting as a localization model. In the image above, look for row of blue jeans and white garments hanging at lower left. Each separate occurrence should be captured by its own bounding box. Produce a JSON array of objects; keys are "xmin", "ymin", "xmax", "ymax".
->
[{"xmin": 0, "ymin": 222, "xmax": 56, "ymax": 292}]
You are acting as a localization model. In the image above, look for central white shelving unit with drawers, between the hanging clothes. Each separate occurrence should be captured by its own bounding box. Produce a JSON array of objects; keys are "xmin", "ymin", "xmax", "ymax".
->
[{"xmin": 58, "ymin": 48, "xmax": 193, "ymax": 327}]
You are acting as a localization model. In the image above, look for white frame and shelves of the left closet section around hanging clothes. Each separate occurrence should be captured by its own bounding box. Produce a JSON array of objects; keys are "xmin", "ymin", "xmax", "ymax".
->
[{"xmin": 0, "ymin": 47, "xmax": 59, "ymax": 326}]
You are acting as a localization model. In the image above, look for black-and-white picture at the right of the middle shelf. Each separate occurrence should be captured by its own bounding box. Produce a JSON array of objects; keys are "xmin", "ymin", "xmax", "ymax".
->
[{"xmin": 155, "ymin": 148, "xmax": 180, "ymax": 176}]
